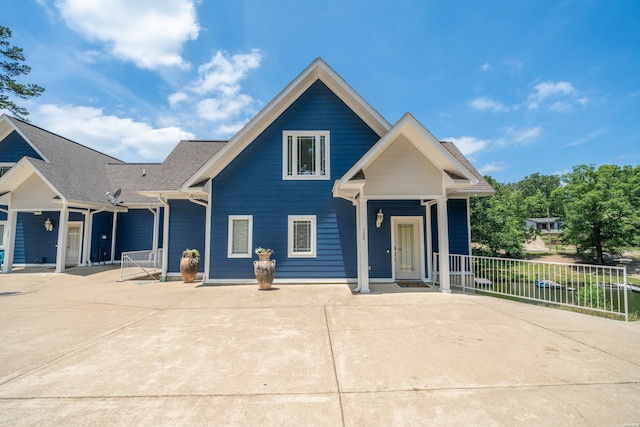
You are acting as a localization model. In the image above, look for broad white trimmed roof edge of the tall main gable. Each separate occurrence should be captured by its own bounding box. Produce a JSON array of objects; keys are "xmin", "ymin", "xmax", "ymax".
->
[{"xmin": 181, "ymin": 58, "xmax": 391, "ymax": 191}]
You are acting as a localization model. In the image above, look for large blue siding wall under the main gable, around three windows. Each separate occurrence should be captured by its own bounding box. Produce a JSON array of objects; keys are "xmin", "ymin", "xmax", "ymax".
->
[{"xmin": 209, "ymin": 81, "xmax": 378, "ymax": 279}]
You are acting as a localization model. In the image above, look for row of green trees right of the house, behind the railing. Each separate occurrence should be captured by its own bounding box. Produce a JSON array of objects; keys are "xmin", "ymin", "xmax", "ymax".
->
[{"xmin": 470, "ymin": 165, "xmax": 640, "ymax": 264}]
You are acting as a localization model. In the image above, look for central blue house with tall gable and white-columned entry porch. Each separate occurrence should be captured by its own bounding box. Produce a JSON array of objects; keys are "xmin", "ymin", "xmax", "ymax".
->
[{"xmin": 145, "ymin": 59, "xmax": 493, "ymax": 293}]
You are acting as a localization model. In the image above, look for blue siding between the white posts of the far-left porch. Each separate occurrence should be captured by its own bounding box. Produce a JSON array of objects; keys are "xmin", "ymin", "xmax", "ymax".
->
[{"xmin": 13, "ymin": 212, "xmax": 60, "ymax": 264}]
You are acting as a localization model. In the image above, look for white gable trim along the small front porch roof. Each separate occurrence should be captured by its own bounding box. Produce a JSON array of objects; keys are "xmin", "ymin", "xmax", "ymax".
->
[{"xmin": 338, "ymin": 113, "xmax": 478, "ymax": 192}]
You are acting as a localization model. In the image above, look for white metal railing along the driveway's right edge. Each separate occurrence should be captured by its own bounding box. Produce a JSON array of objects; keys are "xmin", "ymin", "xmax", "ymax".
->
[{"xmin": 433, "ymin": 253, "xmax": 629, "ymax": 320}]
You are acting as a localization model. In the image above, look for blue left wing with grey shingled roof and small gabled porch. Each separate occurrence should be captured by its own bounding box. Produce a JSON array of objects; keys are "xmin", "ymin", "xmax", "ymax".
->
[{"xmin": 0, "ymin": 115, "xmax": 162, "ymax": 273}]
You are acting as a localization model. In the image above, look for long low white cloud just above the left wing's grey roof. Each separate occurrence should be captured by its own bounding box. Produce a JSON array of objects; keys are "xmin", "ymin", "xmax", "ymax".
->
[{"xmin": 32, "ymin": 104, "xmax": 195, "ymax": 161}]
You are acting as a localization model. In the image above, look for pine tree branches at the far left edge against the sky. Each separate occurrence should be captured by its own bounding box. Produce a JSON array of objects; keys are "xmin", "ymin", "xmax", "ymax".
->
[{"xmin": 0, "ymin": 26, "xmax": 44, "ymax": 119}]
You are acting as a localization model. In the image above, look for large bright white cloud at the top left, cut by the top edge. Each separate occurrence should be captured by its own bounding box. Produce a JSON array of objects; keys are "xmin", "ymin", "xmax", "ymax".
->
[{"xmin": 55, "ymin": 0, "xmax": 200, "ymax": 69}]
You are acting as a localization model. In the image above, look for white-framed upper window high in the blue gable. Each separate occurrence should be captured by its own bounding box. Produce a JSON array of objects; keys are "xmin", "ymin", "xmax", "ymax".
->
[{"xmin": 282, "ymin": 131, "xmax": 329, "ymax": 179}]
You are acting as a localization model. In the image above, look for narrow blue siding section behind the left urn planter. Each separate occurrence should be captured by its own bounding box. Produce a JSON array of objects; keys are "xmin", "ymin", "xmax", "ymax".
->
[{"xmin": 167, "ymin": 200, "xmax": 206, "ymax": 273}]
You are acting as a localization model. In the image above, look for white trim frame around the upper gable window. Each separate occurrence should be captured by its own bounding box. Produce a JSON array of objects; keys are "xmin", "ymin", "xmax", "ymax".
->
[{"xmin": 282, "ymin": 130, "xmax": 331, "ymax": 180}]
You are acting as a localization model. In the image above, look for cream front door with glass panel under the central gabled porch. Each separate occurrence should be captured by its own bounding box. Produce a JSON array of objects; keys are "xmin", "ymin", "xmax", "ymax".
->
[{"xmin": 393, "ymin": 217, "xmax": 424, "ymax": 280}]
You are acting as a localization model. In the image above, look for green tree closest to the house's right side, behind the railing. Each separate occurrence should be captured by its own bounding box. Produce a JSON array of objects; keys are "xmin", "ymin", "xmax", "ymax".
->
[{"xmin": 470, "ymin": 176, "xmax": 534, "ymax": 257}]
